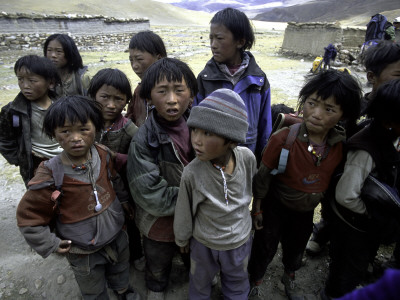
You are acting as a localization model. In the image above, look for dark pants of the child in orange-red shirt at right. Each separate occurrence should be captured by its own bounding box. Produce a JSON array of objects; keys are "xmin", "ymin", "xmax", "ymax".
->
[{"xmin": 249, "ymin": 199, "xmax": 314, "ymax": 282}]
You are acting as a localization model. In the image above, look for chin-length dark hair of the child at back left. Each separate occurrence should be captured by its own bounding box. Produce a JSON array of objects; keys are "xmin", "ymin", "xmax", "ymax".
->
[{"xmin": 43, "ymin": 33, "xmax": 83, "ymax": 72}]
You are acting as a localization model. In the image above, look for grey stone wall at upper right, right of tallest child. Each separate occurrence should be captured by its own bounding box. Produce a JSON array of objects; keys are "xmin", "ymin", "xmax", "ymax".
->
[{"xmin": 282, "ymin": 22, "xmax": 365, "ymax": 57}]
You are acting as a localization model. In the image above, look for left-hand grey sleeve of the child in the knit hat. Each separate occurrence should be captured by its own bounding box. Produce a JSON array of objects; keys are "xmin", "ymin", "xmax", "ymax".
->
[{"xmin": 174, "ymin": 169, "xmax": 195, "ymax": 247}]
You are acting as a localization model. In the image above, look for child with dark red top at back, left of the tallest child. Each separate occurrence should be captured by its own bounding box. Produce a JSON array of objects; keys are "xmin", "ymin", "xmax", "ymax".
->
[{"xmin": 125, "ymin": 30, "xmax": 167, "ymax": 126}]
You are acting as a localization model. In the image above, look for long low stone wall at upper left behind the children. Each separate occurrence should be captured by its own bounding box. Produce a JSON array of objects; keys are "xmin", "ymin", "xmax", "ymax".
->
[{"xmin": 0, "ymin": 13, "xmax": 150, "ymax": 51}]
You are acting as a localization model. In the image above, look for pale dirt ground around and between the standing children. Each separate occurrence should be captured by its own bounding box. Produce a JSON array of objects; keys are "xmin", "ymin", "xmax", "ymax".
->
[{"xmin": 0, "ymin": 24, "xmax": 388, "ymax": 300}]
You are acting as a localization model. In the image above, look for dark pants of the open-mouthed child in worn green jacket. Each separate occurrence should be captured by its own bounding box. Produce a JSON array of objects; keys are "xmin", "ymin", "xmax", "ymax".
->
[{"xmin": 143, "ymin": 236, "xmax": 190, "ymax": 292}]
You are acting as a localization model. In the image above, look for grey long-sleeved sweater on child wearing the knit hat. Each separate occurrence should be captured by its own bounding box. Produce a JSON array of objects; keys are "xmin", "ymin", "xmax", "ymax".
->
[{"xmin": 174, "ymin": 147, "xmax": 257, "ymax": 250}]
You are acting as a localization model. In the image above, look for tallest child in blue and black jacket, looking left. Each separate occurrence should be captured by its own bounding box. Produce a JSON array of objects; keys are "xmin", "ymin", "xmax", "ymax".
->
[{"xmin": 193, "ymin": 8, "xmax": 272, "ymax": 161}]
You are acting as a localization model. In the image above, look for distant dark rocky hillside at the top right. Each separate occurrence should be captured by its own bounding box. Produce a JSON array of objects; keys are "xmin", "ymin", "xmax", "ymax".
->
[{"xmin": 254, "ymin": 0, "xmax": 400, "ymax": 26}]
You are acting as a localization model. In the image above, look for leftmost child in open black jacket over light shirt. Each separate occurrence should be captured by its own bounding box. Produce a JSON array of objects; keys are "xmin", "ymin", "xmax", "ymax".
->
[{"xmin": 0, "ymin": 55, "xmax": 62, "ymax": 185}]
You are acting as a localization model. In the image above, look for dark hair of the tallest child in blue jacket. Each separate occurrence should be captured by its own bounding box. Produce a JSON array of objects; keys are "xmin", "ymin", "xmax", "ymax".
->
[{"xmin": 210, "ymin": 7, "xmax": 255, "ymax": 51}]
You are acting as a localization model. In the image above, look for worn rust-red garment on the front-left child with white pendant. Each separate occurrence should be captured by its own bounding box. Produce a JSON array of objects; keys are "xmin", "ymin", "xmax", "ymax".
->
[{"xmin": 17, "ymin": 146, "xmax": 116, "ymax": 227}]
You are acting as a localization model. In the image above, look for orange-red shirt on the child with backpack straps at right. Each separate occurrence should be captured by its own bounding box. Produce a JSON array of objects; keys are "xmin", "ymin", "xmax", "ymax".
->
[{"xmin": 262, "ymin": 128, "xmax": 343, "ymax": 193}]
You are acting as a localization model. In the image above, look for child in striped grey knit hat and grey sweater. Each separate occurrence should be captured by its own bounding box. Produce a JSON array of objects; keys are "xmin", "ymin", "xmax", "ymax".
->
[{"xmin": 174, "ymin": 89, "xmax": 257, "ymax": 299}]
